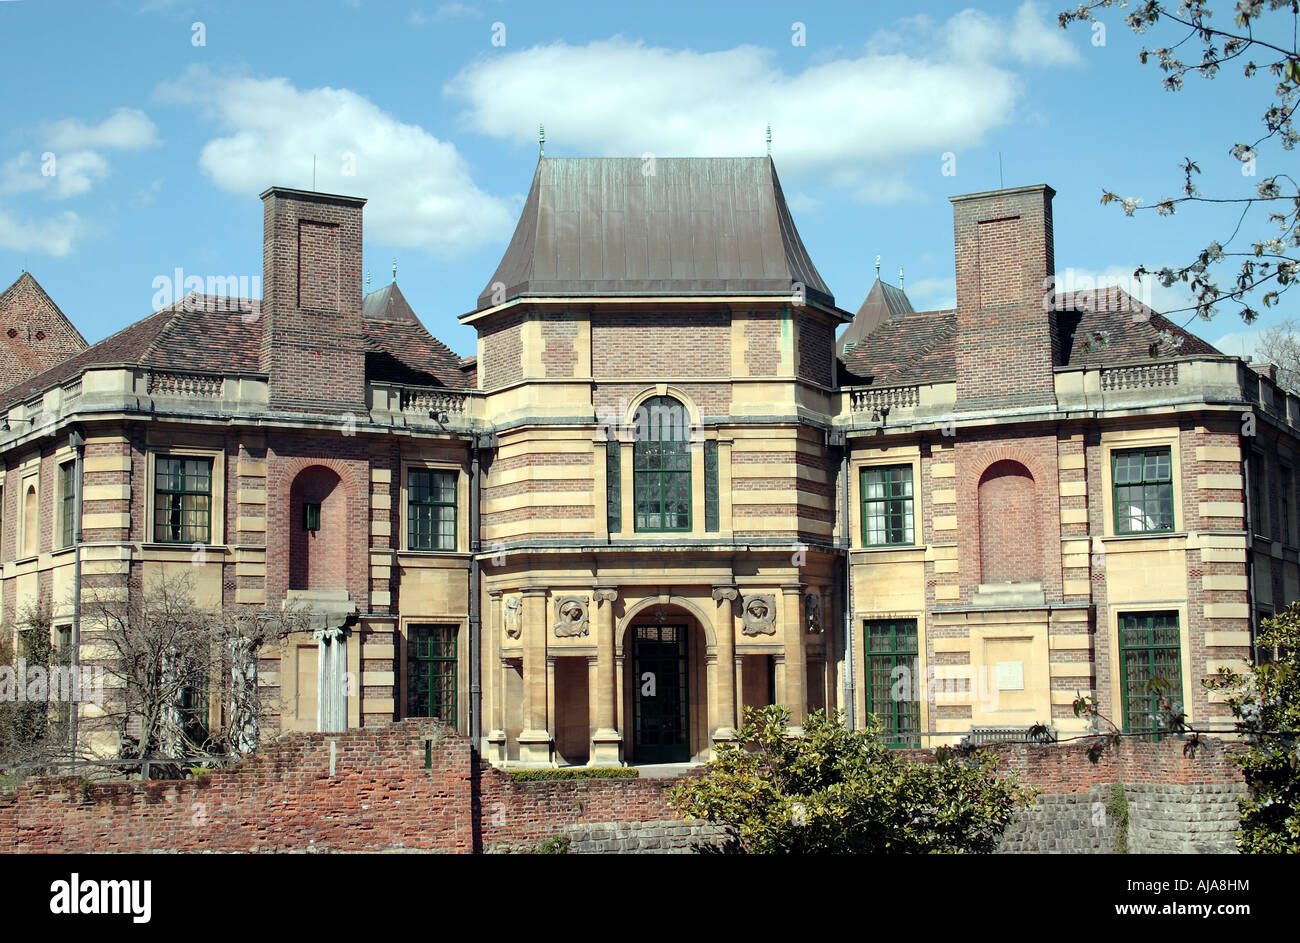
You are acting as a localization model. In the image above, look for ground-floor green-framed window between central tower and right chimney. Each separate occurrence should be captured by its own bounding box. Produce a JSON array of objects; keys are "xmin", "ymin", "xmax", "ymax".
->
[{"xmin": 865, "ymin": 619, "xmax": 922, "ymax": 747}]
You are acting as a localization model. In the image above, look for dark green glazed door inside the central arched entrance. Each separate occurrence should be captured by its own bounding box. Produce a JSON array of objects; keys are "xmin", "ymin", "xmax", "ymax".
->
[{"xmin": 632, "ymin": 626, "xmax": 690, "ymax": 764}]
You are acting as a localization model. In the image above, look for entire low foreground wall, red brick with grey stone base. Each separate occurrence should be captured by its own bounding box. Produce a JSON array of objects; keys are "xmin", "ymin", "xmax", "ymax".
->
[{"xmin": 0, "ymin": 721, "xmax": 1244, "ymax": 852}]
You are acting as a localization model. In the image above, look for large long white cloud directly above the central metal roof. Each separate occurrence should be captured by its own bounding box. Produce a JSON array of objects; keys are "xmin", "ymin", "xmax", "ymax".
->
[{"xmin": 443, "ymin": 4, "xmax": 1079, "ymax": 200}]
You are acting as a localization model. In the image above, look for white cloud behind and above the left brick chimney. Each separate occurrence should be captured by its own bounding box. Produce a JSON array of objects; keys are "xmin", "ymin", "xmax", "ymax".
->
[{"xmin": 156, "ymin": 66, "xmax": 515, "ymax": 256}]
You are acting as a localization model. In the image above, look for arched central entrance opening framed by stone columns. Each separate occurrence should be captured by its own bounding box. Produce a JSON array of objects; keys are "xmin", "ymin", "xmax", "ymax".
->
[{"xmin": 623, "ymin": 605, "xmax": 709, "ymax": 765}]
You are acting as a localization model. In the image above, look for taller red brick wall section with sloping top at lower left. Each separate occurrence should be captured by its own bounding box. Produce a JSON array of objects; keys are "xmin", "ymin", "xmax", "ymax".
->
[{"xmin": 0, "ymin": 721, "xmax": 473, "ymax": 852}]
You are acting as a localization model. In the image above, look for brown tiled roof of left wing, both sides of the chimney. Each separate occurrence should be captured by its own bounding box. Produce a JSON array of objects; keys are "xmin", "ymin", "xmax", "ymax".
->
[{"xmin": 0, "ymin": 285, "xmax": 468, "ymax": 408}]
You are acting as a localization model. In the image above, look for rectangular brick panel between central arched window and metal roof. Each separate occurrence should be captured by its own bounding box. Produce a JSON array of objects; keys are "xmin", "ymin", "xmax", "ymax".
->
[{"xmin": 592, "ymin": 307, "xmax": 731, "ymax": 380}]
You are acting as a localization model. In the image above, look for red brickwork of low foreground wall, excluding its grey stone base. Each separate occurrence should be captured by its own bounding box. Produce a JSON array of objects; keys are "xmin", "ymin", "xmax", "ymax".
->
[{"xmin": 0, "ymin": 721, "xmax": 1240, "ymax": 852}]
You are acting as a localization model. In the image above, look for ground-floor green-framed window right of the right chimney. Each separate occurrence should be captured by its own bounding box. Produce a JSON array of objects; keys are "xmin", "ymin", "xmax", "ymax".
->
[{"xmin": 1119, "ymin": 613, "xmax": 1183, "ymax": 740}]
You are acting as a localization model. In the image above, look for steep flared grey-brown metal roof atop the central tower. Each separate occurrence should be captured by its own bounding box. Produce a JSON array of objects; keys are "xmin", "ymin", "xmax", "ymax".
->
[{"xmin": 476, "ymin": 157, "xmax": 835, "ymax": 311}]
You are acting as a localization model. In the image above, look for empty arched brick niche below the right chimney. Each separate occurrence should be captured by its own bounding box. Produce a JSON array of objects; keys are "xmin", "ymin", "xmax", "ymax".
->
[{"xmin": 976, "ymin": 459, "xmax": 1043, "ymax": 584}]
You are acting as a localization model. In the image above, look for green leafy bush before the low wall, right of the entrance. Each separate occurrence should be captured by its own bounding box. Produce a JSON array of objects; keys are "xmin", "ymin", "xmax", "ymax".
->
[{"xmin": 670, "ymin": 706, "xmax": 1032, "ymax": 853}]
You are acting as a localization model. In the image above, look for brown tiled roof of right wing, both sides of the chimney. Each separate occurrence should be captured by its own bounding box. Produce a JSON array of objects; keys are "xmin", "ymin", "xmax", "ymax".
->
[{"xmin": 840, "ymin": 287, "xmax": 1221, "ymax": 386}]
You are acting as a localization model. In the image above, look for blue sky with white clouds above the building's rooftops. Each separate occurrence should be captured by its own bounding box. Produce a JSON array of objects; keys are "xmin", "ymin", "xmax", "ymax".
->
[{"xmin": 0, "ymin": 0, "xmax": 1291, "ymax": 354}]
